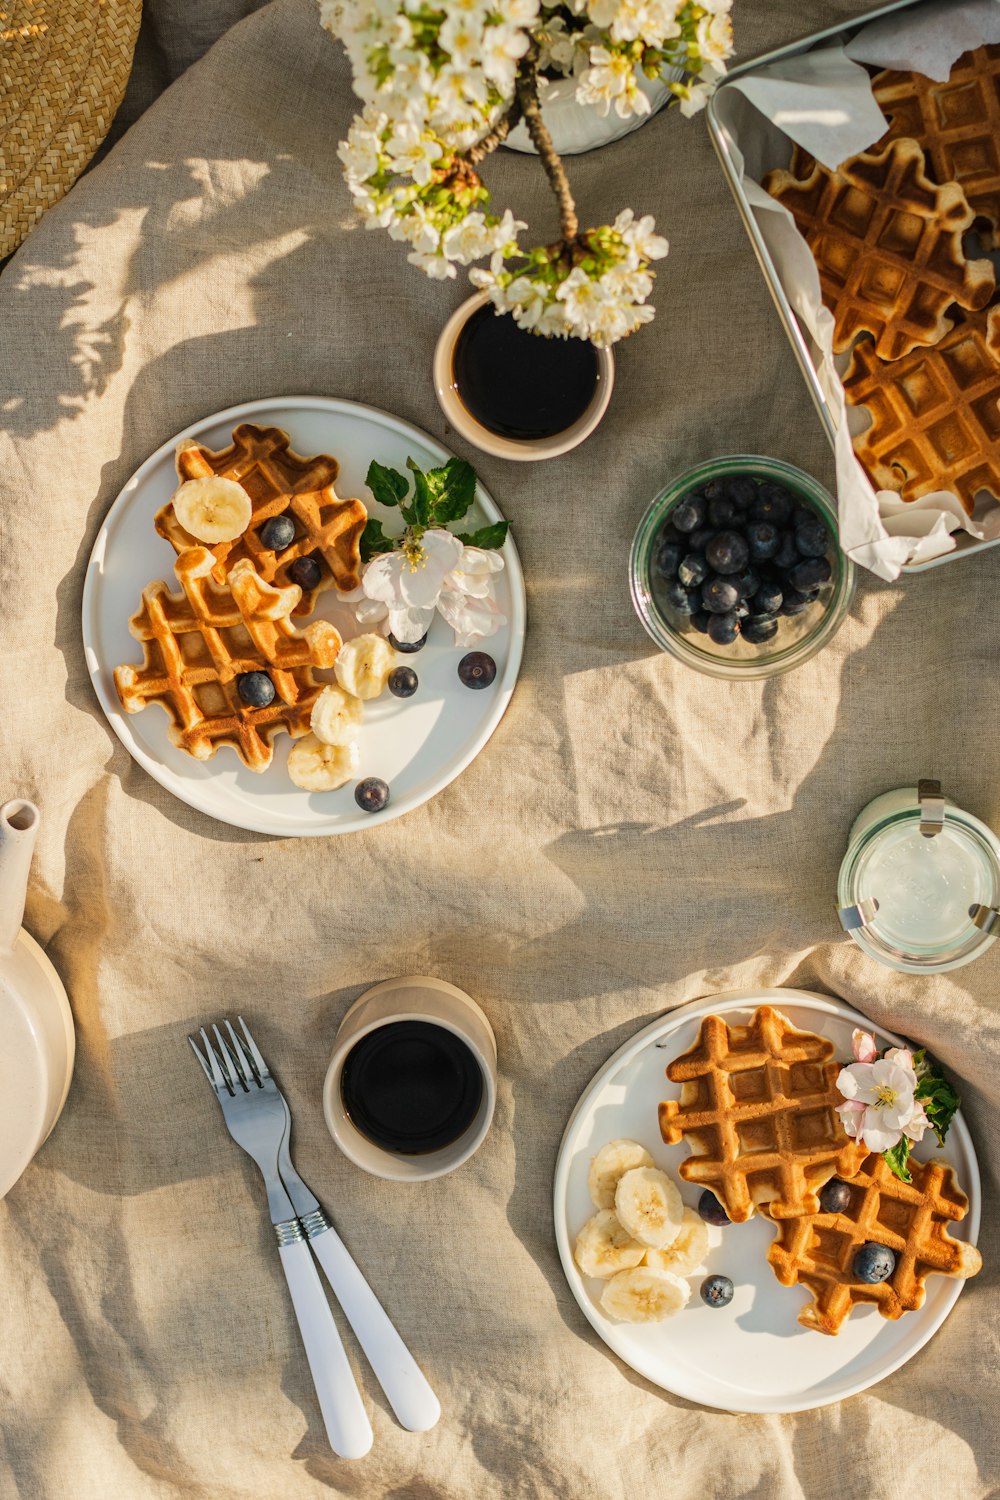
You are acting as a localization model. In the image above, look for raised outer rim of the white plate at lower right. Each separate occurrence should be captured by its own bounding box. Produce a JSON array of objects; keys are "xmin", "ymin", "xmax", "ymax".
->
[{"xmin": 552, "ymin": 989, "xmax": 982, "ymax": 1416}]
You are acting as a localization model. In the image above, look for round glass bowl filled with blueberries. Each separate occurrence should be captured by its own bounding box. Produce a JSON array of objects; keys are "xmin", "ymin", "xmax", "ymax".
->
[{"xmin": 630, "ymin": 455, "xmax": 855, "ymax": 678}]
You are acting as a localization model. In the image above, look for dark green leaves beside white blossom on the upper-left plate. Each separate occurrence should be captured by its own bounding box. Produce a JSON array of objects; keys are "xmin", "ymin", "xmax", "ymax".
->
[{"xmin": 361, "ymin": 458, "xmax": 508, "ymax": 563}]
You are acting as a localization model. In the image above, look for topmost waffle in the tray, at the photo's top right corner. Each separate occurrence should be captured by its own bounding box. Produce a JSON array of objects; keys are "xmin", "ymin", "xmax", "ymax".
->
[{"xmin": 871, "ymin": 47, "xmax": 1000, "ymax": 249}]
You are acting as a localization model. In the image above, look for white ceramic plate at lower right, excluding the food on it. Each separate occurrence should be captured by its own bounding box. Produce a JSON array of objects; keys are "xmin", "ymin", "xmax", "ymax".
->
[{"xmin": 555, "ymin": 990, "xmax": 981, "ymax": 1412}]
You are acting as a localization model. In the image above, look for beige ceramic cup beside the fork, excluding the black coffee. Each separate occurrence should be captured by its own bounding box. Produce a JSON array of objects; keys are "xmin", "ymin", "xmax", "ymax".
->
[{"xmin": 322, "ymin": 975, "xmax": 496, "ymax": 1182}]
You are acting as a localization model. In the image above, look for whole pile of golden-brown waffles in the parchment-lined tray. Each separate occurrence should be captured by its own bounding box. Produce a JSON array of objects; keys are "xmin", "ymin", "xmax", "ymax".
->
[{"xmin": 765, "ymin": 47, "xmax": 1000, "ymax": 515}]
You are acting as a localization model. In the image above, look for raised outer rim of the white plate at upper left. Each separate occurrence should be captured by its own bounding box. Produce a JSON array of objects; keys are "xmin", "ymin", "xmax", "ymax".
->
[{"xmin": 81, "ymin": 396, "xmax": 528, "ymax": 839}]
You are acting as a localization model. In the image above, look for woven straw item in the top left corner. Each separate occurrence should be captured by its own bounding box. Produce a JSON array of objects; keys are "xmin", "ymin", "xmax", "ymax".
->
[{"xmin": 0, "ymin": 0, "xmax": 142, "ymax": 257}]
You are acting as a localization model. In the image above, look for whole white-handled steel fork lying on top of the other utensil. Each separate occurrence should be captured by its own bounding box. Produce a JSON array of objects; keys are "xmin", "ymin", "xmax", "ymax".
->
[{"xmin": 187, "ymin": 1022, "xmax": 372, "ymax": 1458}]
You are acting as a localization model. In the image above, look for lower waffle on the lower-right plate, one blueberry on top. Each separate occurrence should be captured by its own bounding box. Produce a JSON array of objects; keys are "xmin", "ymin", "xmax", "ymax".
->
[{"xmin": 768, "ymin": 1157, "xmax": 982, "ymax": 1334}]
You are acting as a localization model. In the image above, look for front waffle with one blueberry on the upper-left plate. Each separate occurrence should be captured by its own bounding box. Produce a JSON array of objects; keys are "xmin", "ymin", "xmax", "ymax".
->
[{"xmin": 114, "ymin": 548, "xmax": 342, "ymax": 771}]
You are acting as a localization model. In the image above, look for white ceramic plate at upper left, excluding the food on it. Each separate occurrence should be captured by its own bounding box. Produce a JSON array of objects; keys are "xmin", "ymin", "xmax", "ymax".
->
[{"xmin": 82, "ymin": 396, "xmax": 525, "ymax": 837}]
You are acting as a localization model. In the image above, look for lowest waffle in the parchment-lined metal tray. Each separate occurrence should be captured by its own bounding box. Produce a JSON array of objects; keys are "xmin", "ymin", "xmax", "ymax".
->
[{"xmin": 844, "ymin": 308, "xmax": 1000, "ymax": 515}]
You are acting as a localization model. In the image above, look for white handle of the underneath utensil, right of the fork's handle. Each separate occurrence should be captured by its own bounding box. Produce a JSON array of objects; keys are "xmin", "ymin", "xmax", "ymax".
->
[{"xmin": 303, "ymin": 1209, "xmax": 441, "ymax": 1433}]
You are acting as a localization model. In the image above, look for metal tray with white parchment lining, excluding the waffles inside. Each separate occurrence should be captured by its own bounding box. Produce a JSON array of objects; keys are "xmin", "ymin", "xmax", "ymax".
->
[{"xmin": 717, "ymin": 0, "xmax": 1000, "ymax": 579}]
